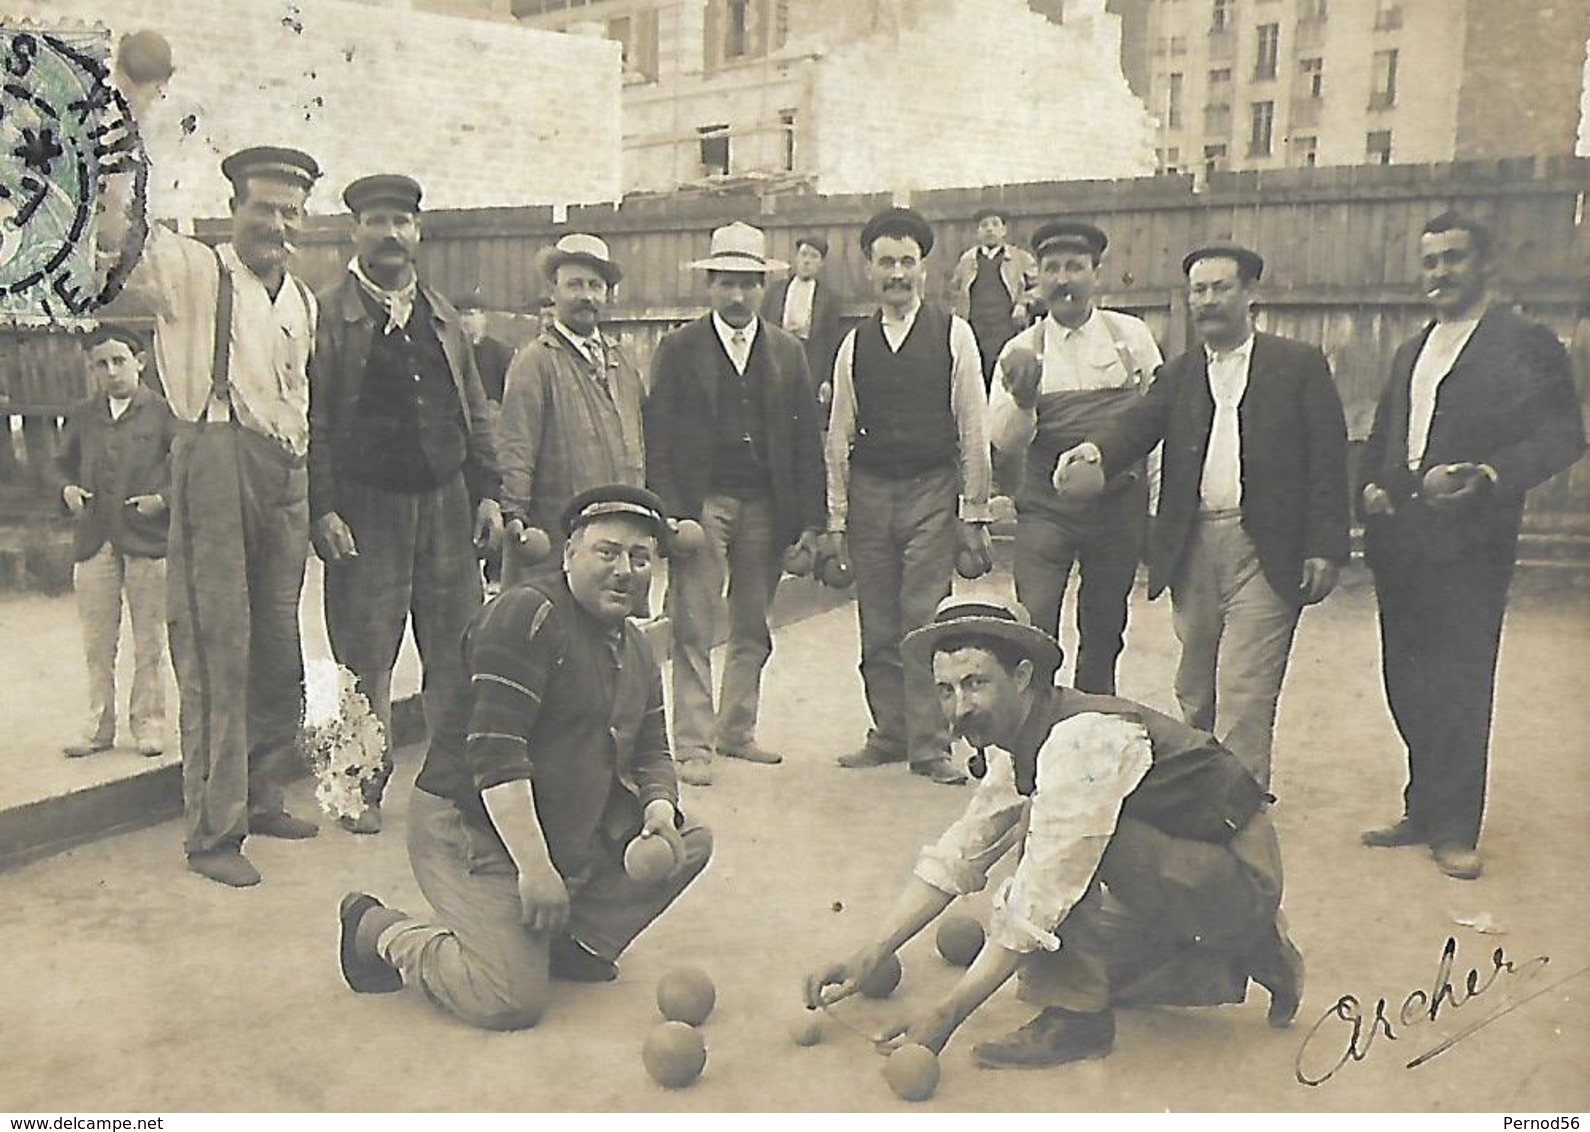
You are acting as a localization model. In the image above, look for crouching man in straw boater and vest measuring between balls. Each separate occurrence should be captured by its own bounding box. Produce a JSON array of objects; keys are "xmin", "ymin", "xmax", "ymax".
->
[{"xmin": 806, "ymin": 598, "xmax": 1302, "ymax": 1068}]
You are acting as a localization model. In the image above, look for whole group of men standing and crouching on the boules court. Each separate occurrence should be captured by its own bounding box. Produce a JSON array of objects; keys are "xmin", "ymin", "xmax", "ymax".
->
[{"xmin": 96, "ymin": 110, "xmax": 1584, "ymax": 1065}]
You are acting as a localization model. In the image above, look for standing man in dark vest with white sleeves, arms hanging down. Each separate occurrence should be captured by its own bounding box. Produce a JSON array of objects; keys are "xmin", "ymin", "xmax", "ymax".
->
[{"xmin": 819, "ymin": 208, "xmax": 992, "ymax": 785}]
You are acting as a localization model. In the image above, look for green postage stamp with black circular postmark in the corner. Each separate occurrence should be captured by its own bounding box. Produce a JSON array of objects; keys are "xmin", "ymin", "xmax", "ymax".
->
[{"xmin": 0, "ymin": 22, "xmax": 148, "ymax": 324}]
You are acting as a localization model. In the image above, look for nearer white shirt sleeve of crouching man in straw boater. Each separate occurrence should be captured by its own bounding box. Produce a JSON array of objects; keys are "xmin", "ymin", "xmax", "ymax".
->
[{"xmin": 989, "ymin": 712, "xmax": 1153, "ymax": 952}]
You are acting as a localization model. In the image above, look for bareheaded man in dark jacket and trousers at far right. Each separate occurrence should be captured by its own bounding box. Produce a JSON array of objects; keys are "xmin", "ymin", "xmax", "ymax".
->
[{"xmin": 1361, "ymin": 213, "xmax": 1585, "ymax": 881}]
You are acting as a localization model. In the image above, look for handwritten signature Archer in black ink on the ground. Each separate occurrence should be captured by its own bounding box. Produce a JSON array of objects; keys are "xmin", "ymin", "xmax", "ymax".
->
[{"xmin": 1294, "ymin": 936, "xmax": 1590, "ymax": 1086}]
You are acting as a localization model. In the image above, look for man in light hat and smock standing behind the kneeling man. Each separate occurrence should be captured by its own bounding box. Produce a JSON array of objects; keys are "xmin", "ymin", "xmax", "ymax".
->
[{"xmin": 498, "ymin": 232, "xmax": 646, "ymax": 585}]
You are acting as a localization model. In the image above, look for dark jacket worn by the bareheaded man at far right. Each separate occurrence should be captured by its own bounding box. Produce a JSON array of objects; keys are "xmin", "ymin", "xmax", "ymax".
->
[{"xmin": 1364, "ymin": 307, "xmax": 1585, "ymax": 564}]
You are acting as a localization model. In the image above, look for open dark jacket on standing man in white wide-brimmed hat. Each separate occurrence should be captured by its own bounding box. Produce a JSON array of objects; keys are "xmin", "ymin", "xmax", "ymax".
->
[{"xmin": 646, "ymin": 315, "xmax": 827, "ymax": 545}]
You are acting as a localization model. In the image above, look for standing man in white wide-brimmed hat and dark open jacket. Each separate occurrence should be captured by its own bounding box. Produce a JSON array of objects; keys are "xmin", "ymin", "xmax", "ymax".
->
[{"xmin": 646, "ymin": 221, "xmax": 824, "ymax": 785}]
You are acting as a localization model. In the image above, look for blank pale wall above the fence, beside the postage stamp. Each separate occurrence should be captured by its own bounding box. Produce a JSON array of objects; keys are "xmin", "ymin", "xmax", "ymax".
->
[{"xmin": 8, "ymin": 0, "xmax": 620, "ymax": 216}]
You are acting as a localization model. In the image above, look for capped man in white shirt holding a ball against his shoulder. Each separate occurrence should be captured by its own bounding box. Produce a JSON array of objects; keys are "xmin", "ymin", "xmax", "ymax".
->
[{"xmin": 989, "ymin": 219, "xmax": 1164, "ymax": 695}]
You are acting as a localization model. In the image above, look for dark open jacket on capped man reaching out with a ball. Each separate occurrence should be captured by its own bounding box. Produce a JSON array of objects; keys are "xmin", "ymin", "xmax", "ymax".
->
[{"xmin": 1089, "ymin": 334, "xmax": 1352, "ymax": 604}]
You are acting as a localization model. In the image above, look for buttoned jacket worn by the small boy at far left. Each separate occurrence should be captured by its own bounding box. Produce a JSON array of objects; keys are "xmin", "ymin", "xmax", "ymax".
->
[{"xmin": 56, "ymin": 386, "xmax": 176, "ymax": 561}]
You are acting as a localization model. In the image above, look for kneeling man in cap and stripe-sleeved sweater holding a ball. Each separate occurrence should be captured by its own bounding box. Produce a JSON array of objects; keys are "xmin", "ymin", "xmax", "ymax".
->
[{"xmin": 339, "ymin": 485, "xmax": 712, "ymax": 1030}]
